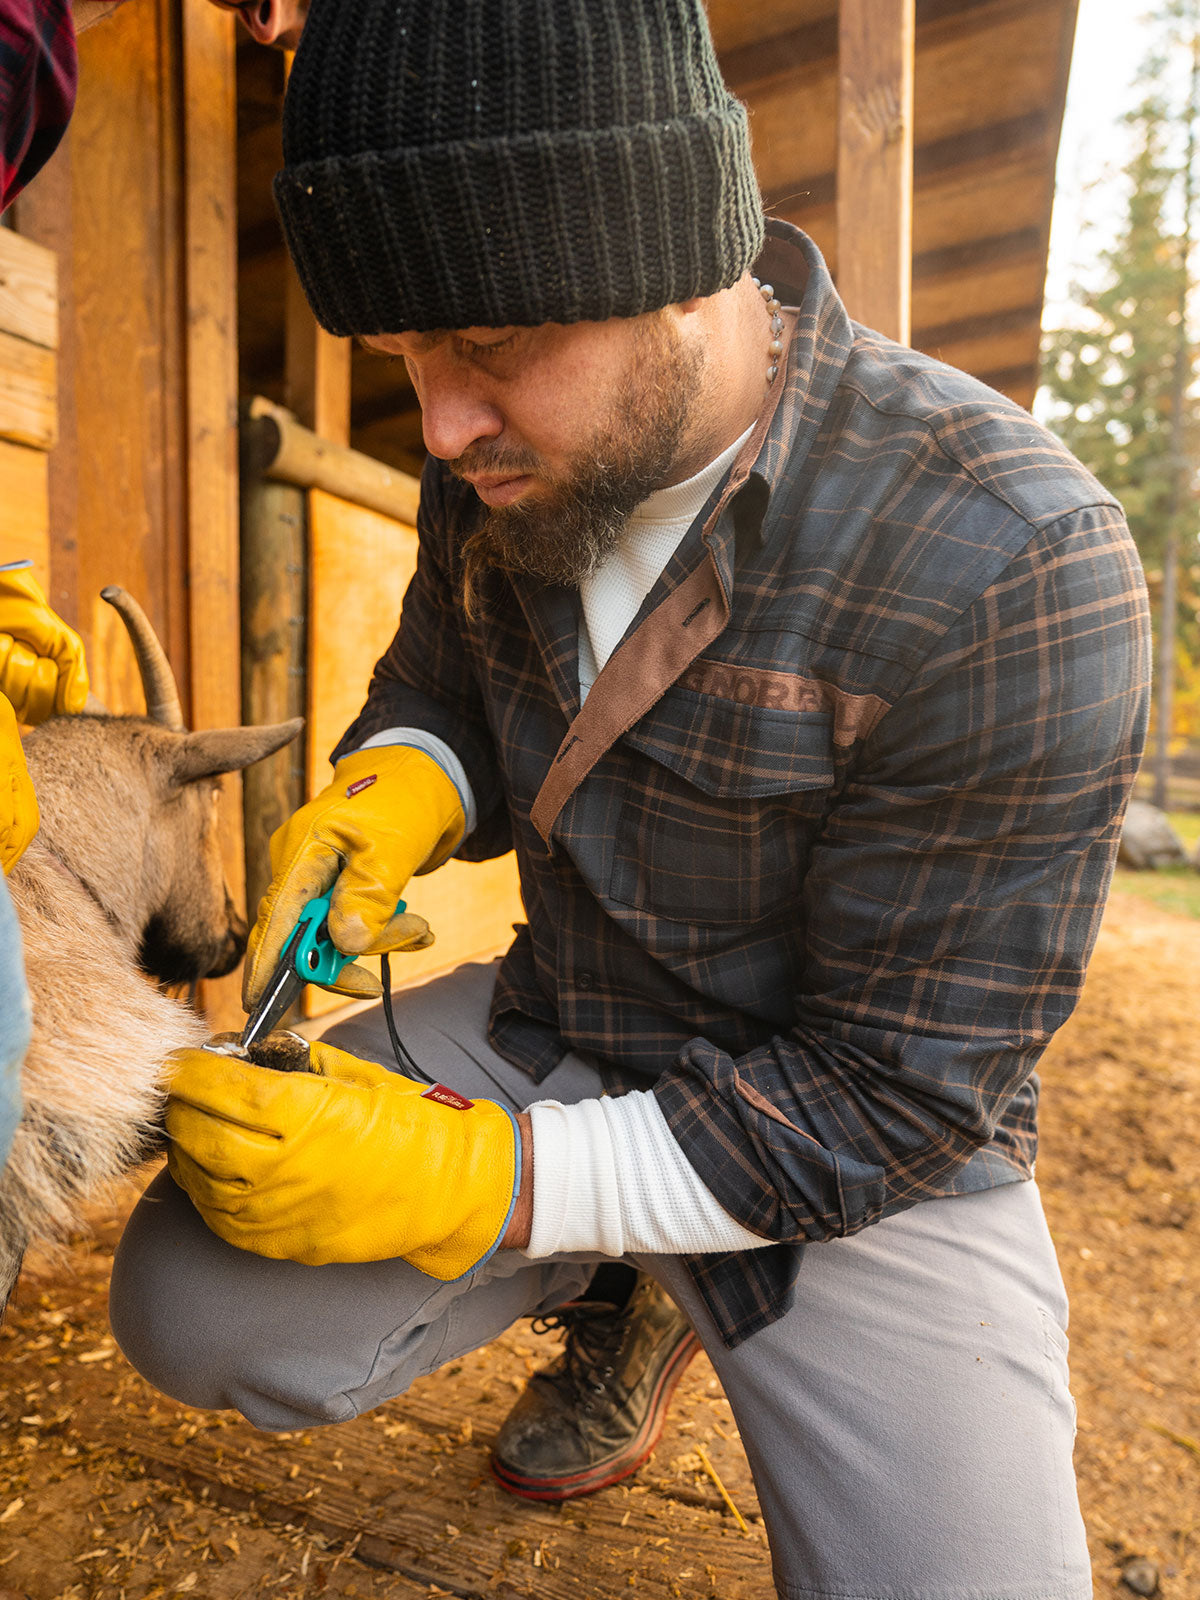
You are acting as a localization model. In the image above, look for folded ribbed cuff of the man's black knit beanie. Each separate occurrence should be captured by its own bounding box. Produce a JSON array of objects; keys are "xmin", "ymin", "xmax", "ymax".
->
[{"xmin": 275, "ymin": 108, "xmax": 763, "ymax": 336}]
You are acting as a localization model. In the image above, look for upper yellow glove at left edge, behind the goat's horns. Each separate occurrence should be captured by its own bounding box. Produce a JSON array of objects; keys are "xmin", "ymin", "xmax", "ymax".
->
[{"xmin": 0, "ymin": 563, "xmax": 88, "ymax": 723}]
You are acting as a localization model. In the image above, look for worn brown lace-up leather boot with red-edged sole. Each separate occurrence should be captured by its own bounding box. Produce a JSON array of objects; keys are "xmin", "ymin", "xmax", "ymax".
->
[{"xmin": 491, "ymin": 1264, "xmax": 701, "ymax": 1501}]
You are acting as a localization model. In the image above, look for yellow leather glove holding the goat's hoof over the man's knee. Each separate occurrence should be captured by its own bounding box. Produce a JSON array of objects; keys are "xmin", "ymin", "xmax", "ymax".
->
[{"xmin": 166, "ymin": 1043, "xmax": 522, "ymax": 1282}]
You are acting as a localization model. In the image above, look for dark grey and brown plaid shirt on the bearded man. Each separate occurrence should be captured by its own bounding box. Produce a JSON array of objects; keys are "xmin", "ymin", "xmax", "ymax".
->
[{"xmin": 339, "ymin": 222, "xmax": 1149, "ymax": 1344}]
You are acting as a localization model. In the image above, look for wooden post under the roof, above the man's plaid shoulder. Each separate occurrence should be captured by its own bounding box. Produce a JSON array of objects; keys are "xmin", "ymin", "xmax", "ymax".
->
[{"xmin": 837, "ymin": 0, "xmax": 915, "ymax": 344}]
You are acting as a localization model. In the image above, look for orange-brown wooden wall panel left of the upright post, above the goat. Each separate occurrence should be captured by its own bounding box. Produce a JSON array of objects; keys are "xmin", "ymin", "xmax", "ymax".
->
[{"xmin": 25, "ymin": 0, "xmax": 190, "ymax": 710}]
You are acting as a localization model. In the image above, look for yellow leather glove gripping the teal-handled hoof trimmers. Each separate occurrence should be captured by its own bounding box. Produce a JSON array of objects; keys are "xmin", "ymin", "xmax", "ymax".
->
[{"xmin": 242, "ymin": 744, "xmax": 466, "ymax": 1011}]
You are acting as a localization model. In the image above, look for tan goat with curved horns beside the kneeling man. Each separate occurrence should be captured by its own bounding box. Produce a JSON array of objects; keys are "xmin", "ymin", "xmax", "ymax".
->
[{"xmin": 0, "ymin": 589, "xmax": 301, "ymax": 1315}]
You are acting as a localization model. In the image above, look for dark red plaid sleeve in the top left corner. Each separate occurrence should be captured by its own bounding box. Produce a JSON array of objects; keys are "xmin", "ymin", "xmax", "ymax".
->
[{"xmin": 0, "ymin": 0, "xmax": 78, "ymax": 210}]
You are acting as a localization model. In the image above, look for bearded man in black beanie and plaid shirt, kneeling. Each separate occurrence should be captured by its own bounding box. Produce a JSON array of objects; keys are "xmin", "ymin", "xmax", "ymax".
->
[{"xmin": 112, "ymin": 0, "xmax": 1147, "ymax": 1600}]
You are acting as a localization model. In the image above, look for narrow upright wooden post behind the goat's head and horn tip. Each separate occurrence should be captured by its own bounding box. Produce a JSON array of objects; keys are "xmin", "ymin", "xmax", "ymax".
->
[{"xmin": 181, "ymin": 5, "xmax": 245, "ymax": 1027}]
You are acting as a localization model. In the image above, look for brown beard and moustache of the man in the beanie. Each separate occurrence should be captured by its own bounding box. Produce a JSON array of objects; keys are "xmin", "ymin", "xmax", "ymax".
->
[{"xmin": 448, "ymin": 320, "xmax": 704, "ymax": 614}]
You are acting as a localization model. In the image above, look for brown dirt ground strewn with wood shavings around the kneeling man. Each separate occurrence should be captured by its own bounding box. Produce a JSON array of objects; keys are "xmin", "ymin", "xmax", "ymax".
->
[{"xmin": 0, "ymin": 894, "xmax": 1200, "ymax": 1600}]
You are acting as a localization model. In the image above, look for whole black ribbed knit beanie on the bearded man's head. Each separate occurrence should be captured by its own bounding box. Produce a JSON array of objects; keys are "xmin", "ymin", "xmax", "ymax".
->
[{"xmin": 275, "ymin": 0, "xmax": 763, "ymax": 334}]
